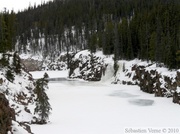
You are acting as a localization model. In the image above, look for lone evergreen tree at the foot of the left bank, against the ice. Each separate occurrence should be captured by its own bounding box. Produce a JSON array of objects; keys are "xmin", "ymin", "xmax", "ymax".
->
[{"xmin": 34, "ymin": 73, "xmax": 52, "ymax": 124}]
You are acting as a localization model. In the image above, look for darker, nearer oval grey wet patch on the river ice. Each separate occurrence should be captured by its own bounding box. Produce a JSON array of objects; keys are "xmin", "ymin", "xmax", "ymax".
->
[{"xmin": 128, "ymin": 99, "xmax": 154, "ymax": 106}]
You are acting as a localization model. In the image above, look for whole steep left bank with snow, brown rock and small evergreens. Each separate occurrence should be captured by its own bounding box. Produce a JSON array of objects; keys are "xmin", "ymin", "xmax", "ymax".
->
[{"xmin": 0, "ymin": 53, "xmax": 35, "ymax": 134}]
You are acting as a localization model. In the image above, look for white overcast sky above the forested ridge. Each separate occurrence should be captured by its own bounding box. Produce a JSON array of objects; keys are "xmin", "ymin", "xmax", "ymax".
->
[{"xmin": 0, "ymin": 0, "xmax": 52, "ymax": 12}]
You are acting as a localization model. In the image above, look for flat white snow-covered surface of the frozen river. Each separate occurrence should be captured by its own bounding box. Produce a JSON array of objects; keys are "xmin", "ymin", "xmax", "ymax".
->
[{"xmin": 31, "ymin": 71, "xmax": 180, "ymax": 134}]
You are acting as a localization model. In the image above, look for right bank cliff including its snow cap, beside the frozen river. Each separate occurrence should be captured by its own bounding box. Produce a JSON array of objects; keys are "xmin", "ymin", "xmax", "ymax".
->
[{"xmin": 116, "ymin": 64, "xmax": 180, "ymax": 104}]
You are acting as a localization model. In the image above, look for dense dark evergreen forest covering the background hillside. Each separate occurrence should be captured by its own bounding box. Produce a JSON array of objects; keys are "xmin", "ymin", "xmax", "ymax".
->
[{"xmin": 0, "ymin": 0, "xmax": 180, "ymax": 68}]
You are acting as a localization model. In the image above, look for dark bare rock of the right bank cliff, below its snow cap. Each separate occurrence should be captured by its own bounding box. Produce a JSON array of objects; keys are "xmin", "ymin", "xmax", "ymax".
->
[{"xmin": 124, "ymin": 65, "xmax": 180, "ymax": 104}]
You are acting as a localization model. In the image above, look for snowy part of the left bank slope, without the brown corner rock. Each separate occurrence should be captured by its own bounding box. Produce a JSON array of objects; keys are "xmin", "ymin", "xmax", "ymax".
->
[{"xmin": 0, "ymin": 54, "xmax": 35, "ymax": 134}]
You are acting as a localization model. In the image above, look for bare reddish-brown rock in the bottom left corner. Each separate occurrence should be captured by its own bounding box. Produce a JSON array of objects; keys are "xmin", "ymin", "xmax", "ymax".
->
[{"xmin": 0, "ymin": 93, "xmax": 15, "ymax": 134}]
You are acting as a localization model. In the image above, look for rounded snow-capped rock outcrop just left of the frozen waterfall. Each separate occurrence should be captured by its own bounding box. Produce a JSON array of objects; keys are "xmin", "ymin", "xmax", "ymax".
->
[{"xmin": 69, "ymin": 50, "xmax": 105, "ymax": 81}]
